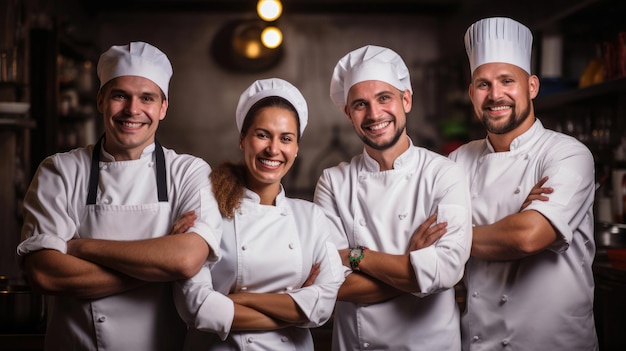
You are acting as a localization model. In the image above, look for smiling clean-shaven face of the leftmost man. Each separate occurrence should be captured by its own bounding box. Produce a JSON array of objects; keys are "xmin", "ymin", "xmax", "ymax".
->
[{"xmin": 98, "ymin": 76, "xmax": 168, "ymax": 161}]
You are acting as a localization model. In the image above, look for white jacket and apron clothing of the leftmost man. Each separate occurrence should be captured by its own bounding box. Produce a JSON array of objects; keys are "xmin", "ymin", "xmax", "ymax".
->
[{"xmin": 17, "ymin": 144, "xmax": 221, "ymax": 351}]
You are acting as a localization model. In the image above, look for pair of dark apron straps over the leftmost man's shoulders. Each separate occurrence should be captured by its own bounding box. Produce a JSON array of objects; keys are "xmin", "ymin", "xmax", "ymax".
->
[{"xmin": 87, "ymin": 135, "xmax": 168, "ymax": 205}]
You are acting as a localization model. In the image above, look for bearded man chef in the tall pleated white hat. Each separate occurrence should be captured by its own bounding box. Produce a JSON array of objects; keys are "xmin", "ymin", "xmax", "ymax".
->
[{"xmin": 450, "ymin": 18, "xmax": 598, "ymax": 351}]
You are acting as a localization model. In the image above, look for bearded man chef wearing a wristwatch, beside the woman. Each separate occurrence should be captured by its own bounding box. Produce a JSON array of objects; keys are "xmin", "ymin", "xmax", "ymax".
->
[{"xmin": 314, "ymin": 45, "xmax": 472, "ymax": 351}]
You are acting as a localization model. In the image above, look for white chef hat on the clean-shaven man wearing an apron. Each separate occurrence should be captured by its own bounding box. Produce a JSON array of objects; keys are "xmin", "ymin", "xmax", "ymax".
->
[{"xmin": 97, "ymin": 41, "xmax": 172, "ymax": 97}]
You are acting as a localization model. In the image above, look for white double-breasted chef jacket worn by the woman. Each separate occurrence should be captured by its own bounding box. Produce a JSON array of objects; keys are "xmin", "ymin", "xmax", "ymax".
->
[{"xmin": 174, "ymin": 189, "xmax": 344, "ymax": 351}]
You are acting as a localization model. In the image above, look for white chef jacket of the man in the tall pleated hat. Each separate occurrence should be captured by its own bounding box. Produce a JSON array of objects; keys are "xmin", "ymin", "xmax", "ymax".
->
[{"xmin": 450, "ymin": 120, "xmax": 598, "ymax": 351}]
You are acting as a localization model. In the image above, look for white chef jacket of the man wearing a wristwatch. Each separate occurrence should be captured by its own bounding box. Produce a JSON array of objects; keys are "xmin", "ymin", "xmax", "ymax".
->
[{"xmin": 314, "ymin": 138, "xmax": 472, "ymax": 351}]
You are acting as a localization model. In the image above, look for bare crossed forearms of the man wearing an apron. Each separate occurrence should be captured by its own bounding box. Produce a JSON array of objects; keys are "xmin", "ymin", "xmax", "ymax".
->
[{"xmin": 24, "ymin": 233, "xmax": 209, "ymax": 298}]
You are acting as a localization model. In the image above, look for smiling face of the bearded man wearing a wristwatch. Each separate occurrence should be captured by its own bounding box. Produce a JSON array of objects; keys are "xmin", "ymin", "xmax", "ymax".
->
[{"xmin": 345, "ymin": 80, "xmax": 411, "ymax": 151}]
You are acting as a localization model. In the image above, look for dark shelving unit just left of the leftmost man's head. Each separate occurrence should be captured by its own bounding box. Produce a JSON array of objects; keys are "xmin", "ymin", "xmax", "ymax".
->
[{"xmin": 29, "ymin": 24, "xmax": 102, "ymax": 172}]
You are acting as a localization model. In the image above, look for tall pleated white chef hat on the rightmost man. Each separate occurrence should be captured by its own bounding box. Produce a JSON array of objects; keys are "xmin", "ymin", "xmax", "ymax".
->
[{"xmin": 465, "ymin": 17, "xmax": 533, "ymax": 74}]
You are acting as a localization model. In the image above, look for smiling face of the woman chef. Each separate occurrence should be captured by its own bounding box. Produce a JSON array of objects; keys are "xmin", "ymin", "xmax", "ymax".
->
[{"xmin": 239, "ymin": 106, "xmax": 298, "ymax": 196}]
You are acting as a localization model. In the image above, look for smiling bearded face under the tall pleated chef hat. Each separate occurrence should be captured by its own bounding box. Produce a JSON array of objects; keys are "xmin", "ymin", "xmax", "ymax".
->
[{"xmin": 469, "ymin": 63, "xmax": 539, "ymax": 137}]
